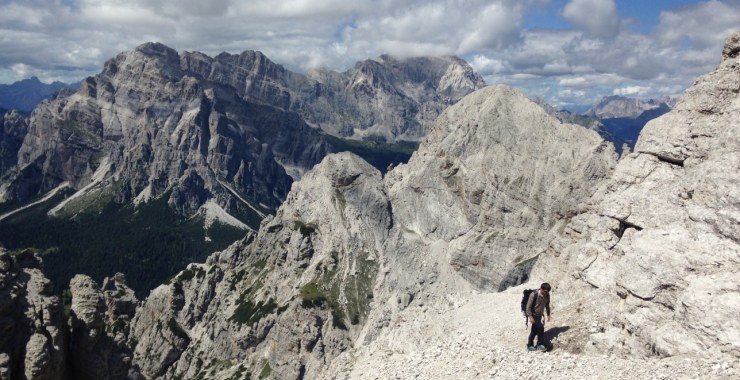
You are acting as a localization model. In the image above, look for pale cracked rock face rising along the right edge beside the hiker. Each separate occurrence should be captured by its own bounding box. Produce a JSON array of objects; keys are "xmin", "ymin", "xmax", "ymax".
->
[{"xmin": 535, "ymin": 30, "xmax": 740, "ymax": 358}]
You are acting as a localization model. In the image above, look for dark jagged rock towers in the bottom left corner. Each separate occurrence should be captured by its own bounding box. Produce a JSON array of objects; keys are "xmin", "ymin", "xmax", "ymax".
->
[{"xmin": 0, "ymin": 248, "xmax": 69, "ymax": 380}]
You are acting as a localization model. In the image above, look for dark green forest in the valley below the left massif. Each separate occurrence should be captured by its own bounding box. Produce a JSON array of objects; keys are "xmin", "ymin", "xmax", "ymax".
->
[{"xmin": 0, "ymin": 194, "xmax": 245, "ymax": 298}]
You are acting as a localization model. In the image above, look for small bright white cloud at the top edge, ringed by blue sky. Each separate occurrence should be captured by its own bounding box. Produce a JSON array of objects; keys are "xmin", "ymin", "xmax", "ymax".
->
[{"xmin": 563, "ymin": 0, "xmax": 619, "ymax": 38}]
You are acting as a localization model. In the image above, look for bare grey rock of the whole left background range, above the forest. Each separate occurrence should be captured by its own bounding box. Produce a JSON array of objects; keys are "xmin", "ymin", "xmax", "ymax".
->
[{"xmin": 0, "ymin": 43, "xmax": 484, "ymax": 228}]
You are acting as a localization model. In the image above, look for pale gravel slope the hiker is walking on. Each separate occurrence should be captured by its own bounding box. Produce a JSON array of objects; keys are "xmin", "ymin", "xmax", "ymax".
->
[{"xmin": 331, "ymin": 286, "xmax": 740, "ymax": 380}]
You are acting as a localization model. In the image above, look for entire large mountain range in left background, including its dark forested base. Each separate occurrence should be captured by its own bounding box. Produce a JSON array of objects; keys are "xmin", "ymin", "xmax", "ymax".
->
[{"xmin": 0, "ymin": 43, "xmax": 484, "ymax": 292}]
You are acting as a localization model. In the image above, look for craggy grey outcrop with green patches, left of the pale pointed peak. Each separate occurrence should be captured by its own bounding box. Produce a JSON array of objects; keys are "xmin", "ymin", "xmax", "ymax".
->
[{"xmin": 131, "ymin": 153, "xmax": 391, "ymax": 378}]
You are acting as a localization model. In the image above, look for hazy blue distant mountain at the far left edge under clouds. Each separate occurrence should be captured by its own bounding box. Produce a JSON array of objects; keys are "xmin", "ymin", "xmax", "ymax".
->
[{"xmin": 0, "ymin": 77, "xmax": 79, "ymax": 112}]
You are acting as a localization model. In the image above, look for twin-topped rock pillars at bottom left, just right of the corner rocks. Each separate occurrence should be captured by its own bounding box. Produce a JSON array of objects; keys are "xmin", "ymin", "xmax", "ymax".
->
[{"xmin": 69, "ymin": 273, "xmax": 140, "ymax": 379}]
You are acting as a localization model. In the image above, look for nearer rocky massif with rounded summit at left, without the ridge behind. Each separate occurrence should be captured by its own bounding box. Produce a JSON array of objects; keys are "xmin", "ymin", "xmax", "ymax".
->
[{"xmin": 2, "ymin": 43, "xmax": 326, "ymax": 223}]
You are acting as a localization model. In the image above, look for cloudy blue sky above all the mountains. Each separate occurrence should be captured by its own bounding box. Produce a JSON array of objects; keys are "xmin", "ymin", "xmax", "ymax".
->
[{"xmin": 0, "ymin": 0, "xmax": 740, "ymax": 109}]
